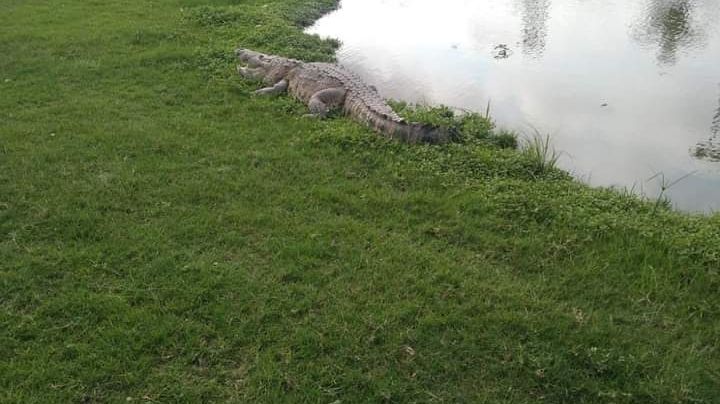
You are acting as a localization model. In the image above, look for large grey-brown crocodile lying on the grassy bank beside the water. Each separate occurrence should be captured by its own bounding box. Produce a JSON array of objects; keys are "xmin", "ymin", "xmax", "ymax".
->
[{"xmin": 235, "ymin": 48, "xmax": 451, "ymax": 143}]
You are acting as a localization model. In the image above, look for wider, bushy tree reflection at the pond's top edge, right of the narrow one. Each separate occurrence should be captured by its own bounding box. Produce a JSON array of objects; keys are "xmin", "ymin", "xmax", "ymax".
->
[{"xmin": 636, "ymin": 0, "xmax": 701, "ymax": 65}]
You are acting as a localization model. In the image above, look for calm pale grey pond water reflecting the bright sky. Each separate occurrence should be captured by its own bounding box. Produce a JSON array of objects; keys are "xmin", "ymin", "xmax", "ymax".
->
[{"xmin": 309, "ymin": 0, "xmax": 720, "ymax": 212}]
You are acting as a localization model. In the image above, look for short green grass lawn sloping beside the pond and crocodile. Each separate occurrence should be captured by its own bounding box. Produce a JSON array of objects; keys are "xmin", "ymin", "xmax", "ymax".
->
[{"xmin": 0, "ymin": 0, "xmax": 720, "ymax": 403}]
